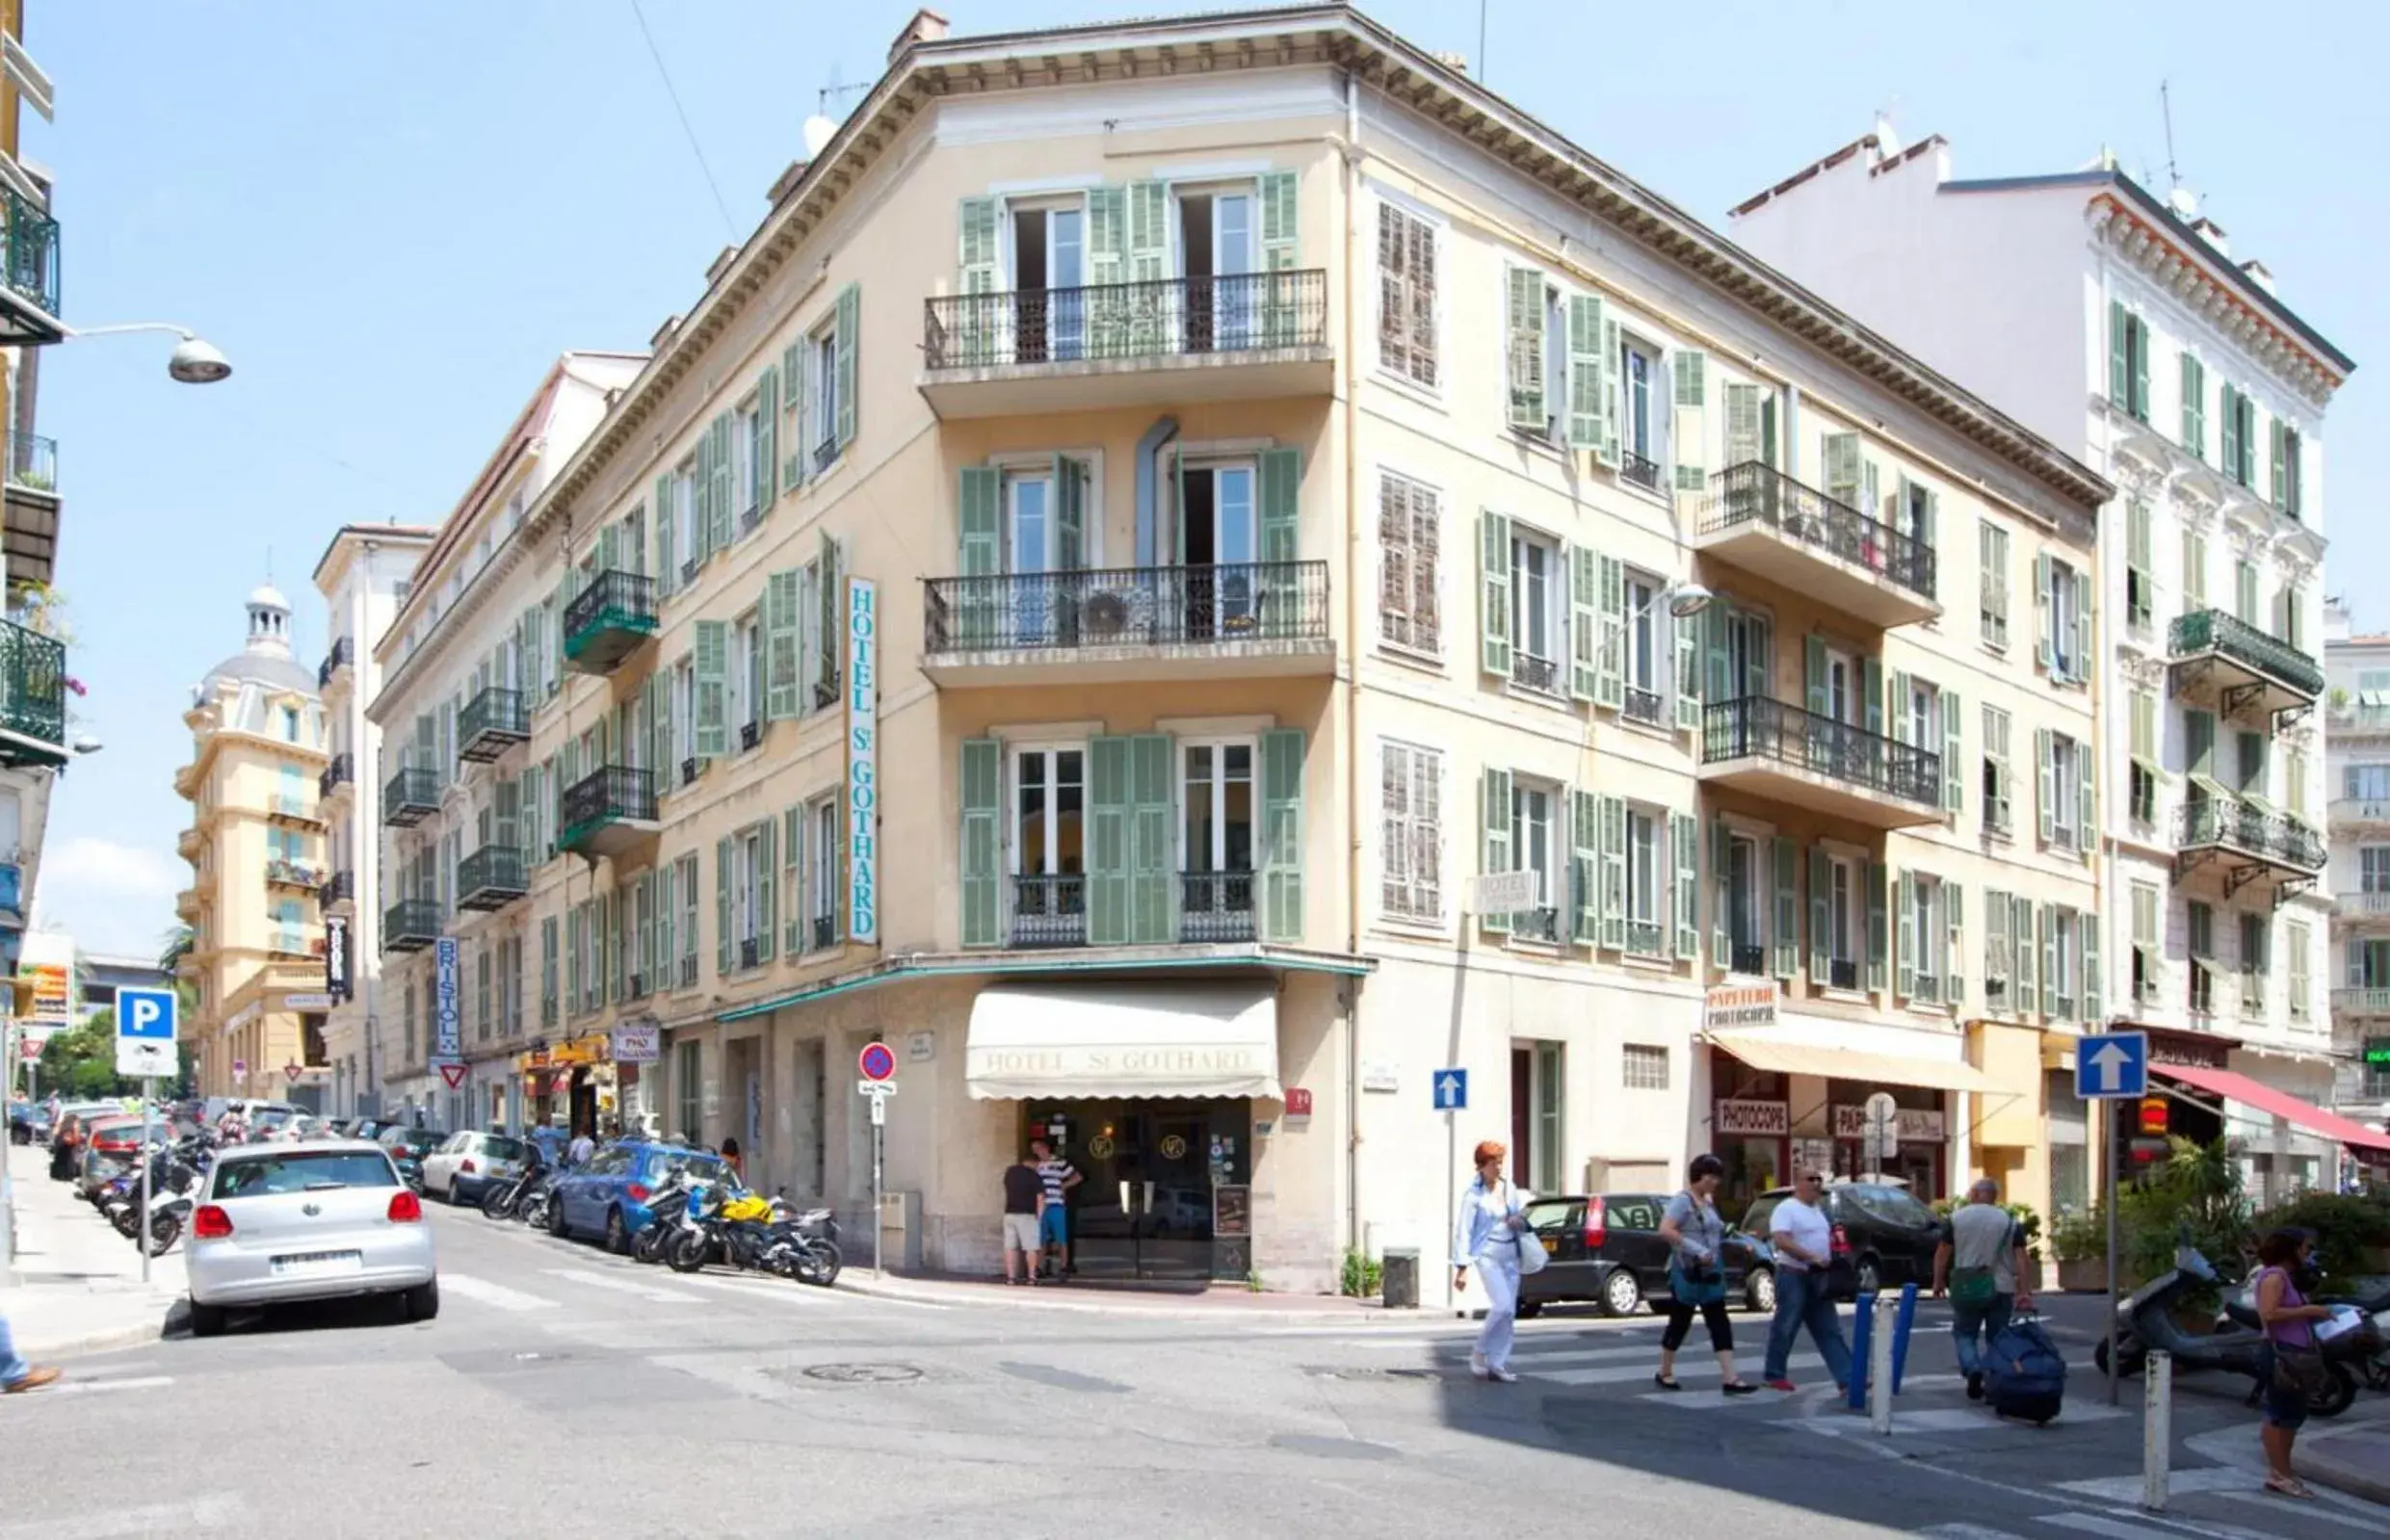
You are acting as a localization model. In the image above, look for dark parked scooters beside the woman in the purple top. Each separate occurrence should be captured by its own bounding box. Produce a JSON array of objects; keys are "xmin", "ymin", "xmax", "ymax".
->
[{"xmin": 2093, "ymin": 1241, "xmax": 2390, "ymax": 1418}]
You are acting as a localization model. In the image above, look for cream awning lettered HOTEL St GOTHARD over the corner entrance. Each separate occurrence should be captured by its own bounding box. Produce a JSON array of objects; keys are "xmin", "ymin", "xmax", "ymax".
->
[{"xmin": 963, "ymin": 980, "xmax": 1278, "ymax": 1100}]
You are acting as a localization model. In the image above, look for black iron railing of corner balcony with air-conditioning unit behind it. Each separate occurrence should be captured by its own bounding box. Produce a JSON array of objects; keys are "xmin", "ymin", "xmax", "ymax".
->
[{"xmin": 925, "ymin": 561, "xmax": 1328, "ymax": 655}]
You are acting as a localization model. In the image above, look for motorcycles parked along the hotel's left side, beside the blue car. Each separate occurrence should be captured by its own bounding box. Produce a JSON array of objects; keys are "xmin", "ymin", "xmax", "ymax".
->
[{"xmin": 470, "ymin": 1162, "xmax": 846, "ymax": 1289}]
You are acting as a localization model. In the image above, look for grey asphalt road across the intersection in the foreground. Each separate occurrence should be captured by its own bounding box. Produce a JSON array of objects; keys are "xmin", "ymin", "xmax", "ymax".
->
[{"xmin": 0, "ymin": 1208, "xmax": 2390, "ymax": 1540}]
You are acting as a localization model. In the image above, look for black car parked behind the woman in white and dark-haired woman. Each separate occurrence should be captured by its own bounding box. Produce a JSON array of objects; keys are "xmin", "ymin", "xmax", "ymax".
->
[{"xmin": 1517, "ymin": 1193, "xmax": 1775, "ymax": 1318}]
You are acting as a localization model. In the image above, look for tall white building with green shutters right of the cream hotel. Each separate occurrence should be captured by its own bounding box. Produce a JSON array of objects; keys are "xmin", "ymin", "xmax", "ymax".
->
[{"xmin": 1730, "ymin": 127, "xmax": 2361, "ymax": 1195}]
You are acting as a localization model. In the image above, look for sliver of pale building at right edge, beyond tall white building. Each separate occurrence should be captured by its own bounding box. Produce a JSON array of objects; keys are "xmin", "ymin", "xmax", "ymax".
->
[{"xmin": 2324, "ymin": 598, "xmax": 2390, "ymax": 1129}]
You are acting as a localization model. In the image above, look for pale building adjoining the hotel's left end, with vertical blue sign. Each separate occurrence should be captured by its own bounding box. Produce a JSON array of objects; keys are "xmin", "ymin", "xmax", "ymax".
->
[{"xmin": 356, "ymin": 352, "xmax": 643, "ymax": 1129}]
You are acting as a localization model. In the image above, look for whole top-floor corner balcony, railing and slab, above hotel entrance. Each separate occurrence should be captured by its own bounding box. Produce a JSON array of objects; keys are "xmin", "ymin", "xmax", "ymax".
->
[{"xmin": 920, "ymin": 268, "xmax": 1336, "ymax": 419}]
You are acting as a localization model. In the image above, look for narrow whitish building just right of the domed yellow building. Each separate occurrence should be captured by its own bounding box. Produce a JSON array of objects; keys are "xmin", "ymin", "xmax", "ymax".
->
[{"xmin": 315, "ymin": 524, "xmax": 437, "ymax": 1117}]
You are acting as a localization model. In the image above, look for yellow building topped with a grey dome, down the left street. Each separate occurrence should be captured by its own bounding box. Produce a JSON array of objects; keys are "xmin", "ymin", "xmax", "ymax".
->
[{"xmin": 174, "ymin": 586, "xmax": 329, "ymax": 1108}]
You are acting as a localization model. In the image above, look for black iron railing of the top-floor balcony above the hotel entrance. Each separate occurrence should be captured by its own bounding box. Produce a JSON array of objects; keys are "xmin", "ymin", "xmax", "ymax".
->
[{"xmin": 923, "ymin": 268, "xmax": 1328, "ymax": 368}]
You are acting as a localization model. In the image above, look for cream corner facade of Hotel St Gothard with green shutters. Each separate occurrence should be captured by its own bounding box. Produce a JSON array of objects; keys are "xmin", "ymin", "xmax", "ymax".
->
[{"xmin": 391, "ymin": 7, "xmax": 2108, "ymax": 1296}]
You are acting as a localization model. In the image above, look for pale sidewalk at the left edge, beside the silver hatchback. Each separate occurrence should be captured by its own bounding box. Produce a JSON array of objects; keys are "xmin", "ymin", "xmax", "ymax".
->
[{"xmin": 0, "ymin": 1160, "xmax": 184, "ymax": 1358}]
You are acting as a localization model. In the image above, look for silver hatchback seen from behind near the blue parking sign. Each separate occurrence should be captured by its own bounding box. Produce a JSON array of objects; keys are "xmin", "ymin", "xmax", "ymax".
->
[{"xmin": 184, "ymin": 1138, "xmax": 440, "ymax": 1337}]
